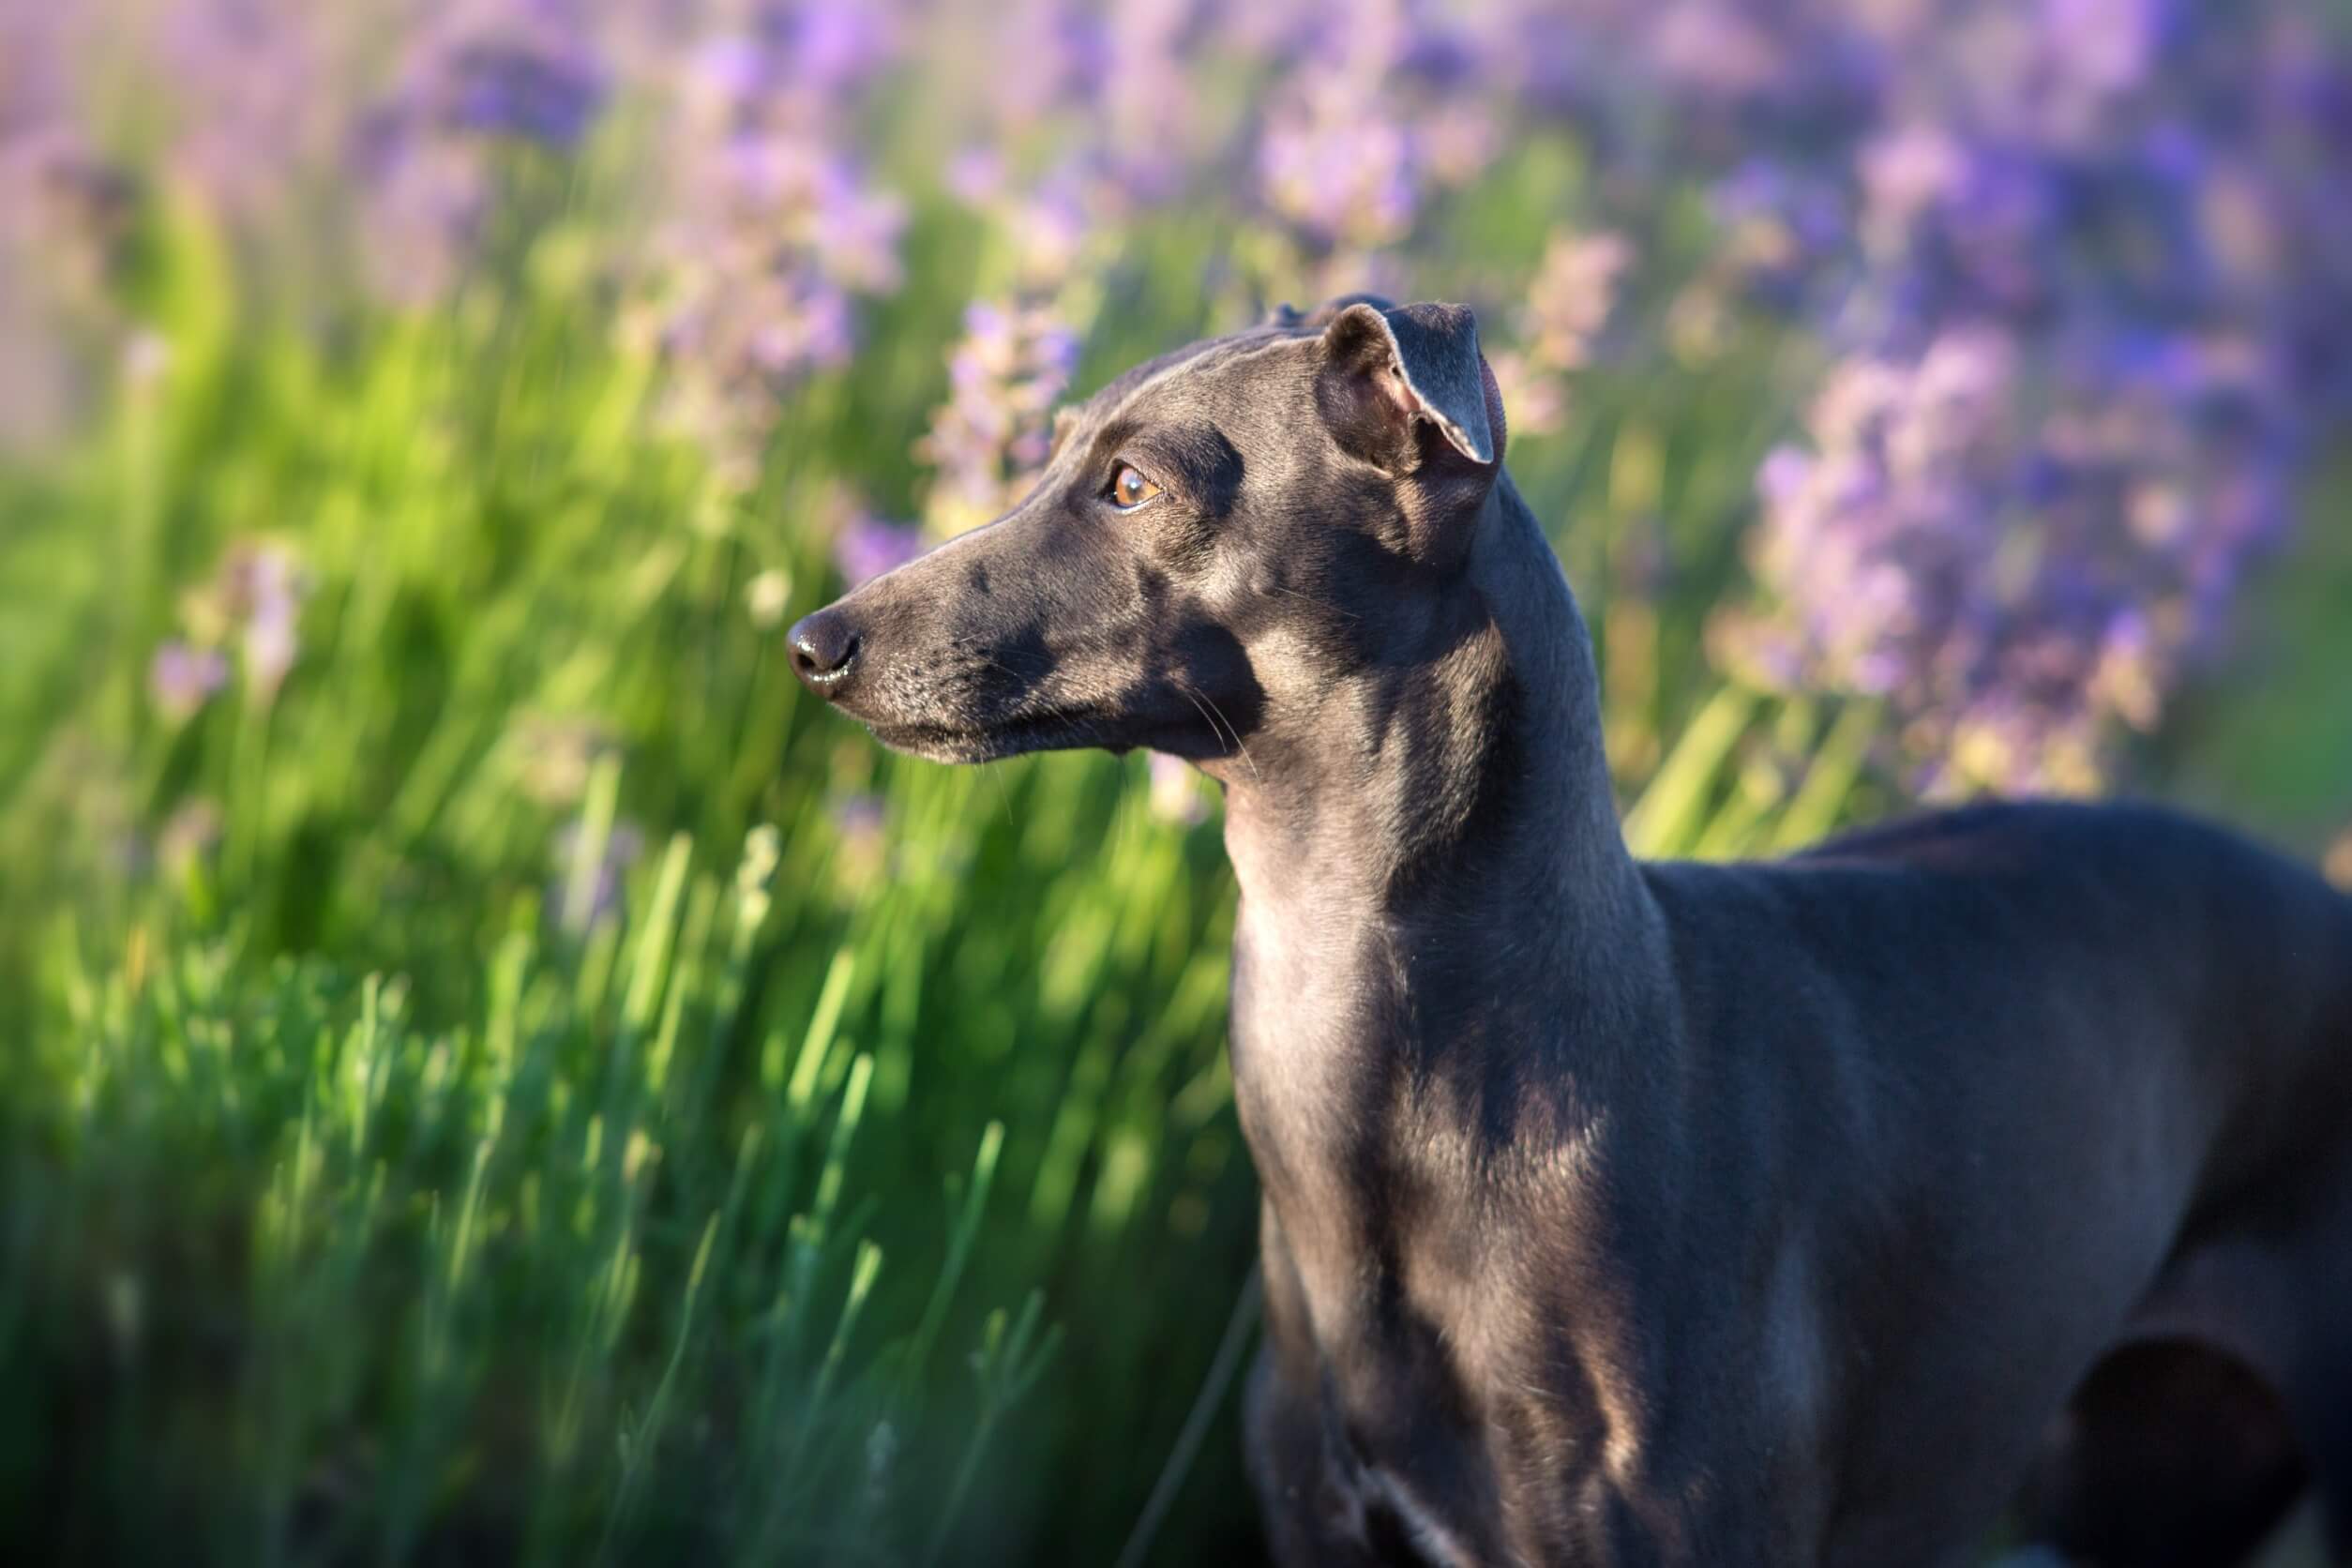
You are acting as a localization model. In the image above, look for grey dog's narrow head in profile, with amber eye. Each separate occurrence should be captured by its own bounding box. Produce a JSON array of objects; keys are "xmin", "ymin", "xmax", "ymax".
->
[{"xmin": 791, "ymin": 298, "xmax": 1503, "ymax": 761}]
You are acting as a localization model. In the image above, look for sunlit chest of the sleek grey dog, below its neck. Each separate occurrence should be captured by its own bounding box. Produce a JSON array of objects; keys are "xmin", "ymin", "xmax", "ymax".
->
[{"xmin": 1232, "ymin": 896, "xmax": 1693, "ymax": 1563}]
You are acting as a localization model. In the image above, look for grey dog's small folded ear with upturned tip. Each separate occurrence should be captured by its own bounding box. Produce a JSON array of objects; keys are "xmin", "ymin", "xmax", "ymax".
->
[{"xmin": 1315, "ymin": 301, "xmax": 1503, "ymax": 477}]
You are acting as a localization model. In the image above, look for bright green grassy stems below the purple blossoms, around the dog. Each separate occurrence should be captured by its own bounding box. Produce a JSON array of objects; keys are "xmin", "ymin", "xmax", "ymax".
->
[{"xmin": 0, "ymin": 145, "xmax": 2352, "ymax": 1563}]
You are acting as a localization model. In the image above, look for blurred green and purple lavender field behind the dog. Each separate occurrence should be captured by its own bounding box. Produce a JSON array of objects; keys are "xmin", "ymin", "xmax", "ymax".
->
[{"xmin": 0, "ymin": 0, "xmax": 2352, "ymax": 1563}]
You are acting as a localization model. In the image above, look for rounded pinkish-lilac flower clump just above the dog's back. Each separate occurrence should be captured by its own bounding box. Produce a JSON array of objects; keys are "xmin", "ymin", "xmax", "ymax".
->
[{"xmin": 1726, "ymin": 326, "xmax": 2282, "ymax": 792}]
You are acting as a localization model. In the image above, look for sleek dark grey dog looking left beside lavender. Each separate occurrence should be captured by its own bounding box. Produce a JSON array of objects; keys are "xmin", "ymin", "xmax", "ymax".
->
[{"xmin": 788, "ymin": 296, "xmax": 2352, "ymax": 1568}]
